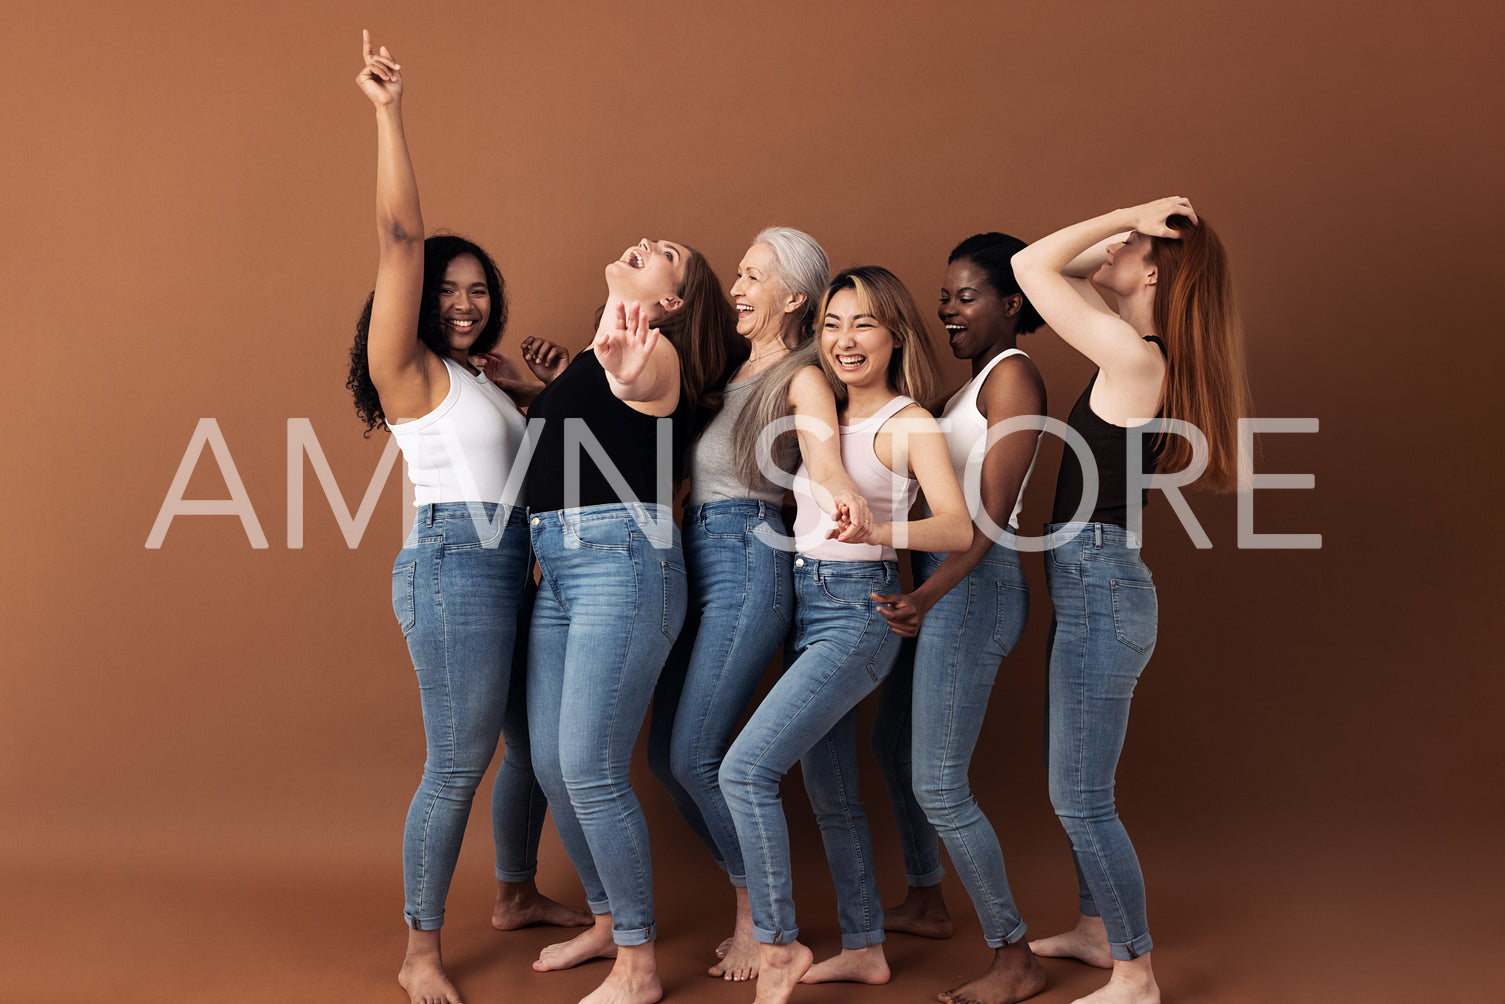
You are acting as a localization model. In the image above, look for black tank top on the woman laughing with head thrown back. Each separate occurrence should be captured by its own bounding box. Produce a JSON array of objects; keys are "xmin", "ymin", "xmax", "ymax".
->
[{"xmin": 525, "ymin": 349, "xmax": 691, "ymax": 512}]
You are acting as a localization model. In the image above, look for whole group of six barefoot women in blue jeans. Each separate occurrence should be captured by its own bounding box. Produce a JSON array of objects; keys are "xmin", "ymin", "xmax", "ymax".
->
[{"xmin": 349, "ymin": 35, "xmax": 1245, "ymax": 1004}]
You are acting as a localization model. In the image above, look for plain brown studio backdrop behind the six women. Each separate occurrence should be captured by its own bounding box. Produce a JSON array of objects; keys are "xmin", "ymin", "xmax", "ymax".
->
[{"xmin": 0, "ymin": 2, "xmax": 1505, "ymax": 999}]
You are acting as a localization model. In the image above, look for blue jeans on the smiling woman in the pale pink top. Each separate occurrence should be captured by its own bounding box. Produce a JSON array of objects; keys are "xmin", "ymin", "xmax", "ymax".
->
[{"xmin": 721, "ymin": 557, "xmax": 898, "ymax": 948}]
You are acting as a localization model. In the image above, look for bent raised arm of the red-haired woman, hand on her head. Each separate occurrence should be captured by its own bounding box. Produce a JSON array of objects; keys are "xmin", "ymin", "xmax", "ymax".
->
[{"xmin": 1013, "ymin": 197, "xmax": 1196, "ymax": 375}]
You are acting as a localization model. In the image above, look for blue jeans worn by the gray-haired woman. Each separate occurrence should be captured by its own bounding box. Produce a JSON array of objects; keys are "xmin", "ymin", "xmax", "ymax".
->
[{"xmin": 649, "ymin": 498, "xmax": 795, "ymax": 885}]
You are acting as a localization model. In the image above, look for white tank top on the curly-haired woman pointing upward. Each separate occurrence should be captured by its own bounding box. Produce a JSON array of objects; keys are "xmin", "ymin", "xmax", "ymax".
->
[{"xmin": 387, "ymin": 357, "xmax": 527, "ymax": 506}]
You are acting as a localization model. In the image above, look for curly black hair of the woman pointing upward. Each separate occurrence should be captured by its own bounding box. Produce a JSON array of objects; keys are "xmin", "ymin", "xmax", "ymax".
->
[{"xmin": 345, "ymin": 233, "xmax": 507, "ymax": 437}]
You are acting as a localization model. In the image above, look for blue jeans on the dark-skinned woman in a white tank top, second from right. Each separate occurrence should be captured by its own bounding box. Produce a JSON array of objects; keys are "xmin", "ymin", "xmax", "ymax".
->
[{"xmin": 873, "ymin": 543, "xmax": 1029, "ymax": 948}]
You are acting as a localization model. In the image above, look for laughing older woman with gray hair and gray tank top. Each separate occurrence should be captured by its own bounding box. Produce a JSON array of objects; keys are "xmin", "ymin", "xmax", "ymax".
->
[{"xmin": 649, "ymin": 227, "xmax": 870, "ymax": 980}]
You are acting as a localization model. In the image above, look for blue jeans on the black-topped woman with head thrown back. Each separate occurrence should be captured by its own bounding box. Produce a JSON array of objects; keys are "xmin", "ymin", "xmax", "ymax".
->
[{"xmin": 528, "ymin": 504, "xmax": 685, "ymax": 945}]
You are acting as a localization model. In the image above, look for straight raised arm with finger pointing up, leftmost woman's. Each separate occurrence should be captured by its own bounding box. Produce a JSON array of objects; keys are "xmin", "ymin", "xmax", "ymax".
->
[{"xmin": 355, "ymin": 32, "xmax": 430, "ymax": 418}]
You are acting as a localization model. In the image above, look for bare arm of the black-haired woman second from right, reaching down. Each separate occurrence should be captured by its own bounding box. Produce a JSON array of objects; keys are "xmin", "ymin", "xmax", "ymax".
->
[{"xmin": 877, "ymin": 358, "xmax": 1046, "ymax": 638}]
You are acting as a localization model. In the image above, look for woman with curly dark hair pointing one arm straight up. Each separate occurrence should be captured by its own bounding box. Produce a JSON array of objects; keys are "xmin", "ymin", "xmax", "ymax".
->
[{"xmin": 348, "ymin": 33, "xmax": 588, "ymax": 1004}]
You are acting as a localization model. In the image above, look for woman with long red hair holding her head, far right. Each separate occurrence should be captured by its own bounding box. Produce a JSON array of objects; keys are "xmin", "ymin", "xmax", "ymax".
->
[{"xmin": 1017, "ymin": 197, "xmax": 1249, "ymax": 1004}]
